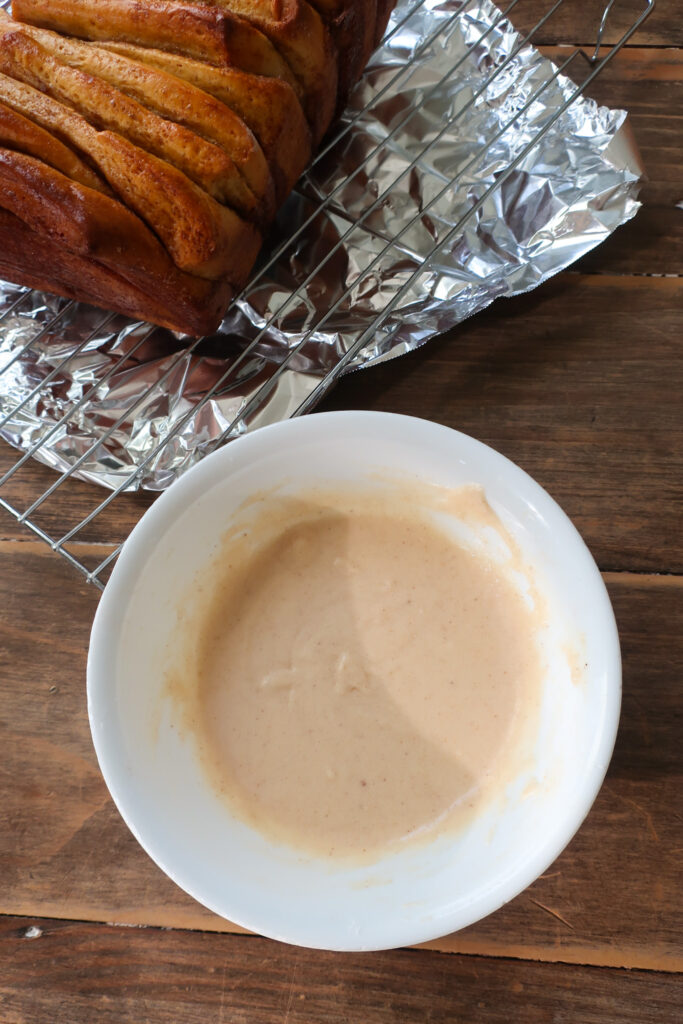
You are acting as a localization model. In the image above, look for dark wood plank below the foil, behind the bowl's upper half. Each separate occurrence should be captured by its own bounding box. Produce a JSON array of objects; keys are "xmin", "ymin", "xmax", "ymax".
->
[{"xmin": 0, "ymin": 273, "xmax": 683, "ymax": 571}]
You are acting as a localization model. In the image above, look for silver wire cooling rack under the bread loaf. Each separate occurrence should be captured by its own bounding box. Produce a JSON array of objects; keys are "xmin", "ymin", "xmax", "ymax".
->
[{"xmin": 0, "ymin": 0, "xmax": 654, "ymax": 589}]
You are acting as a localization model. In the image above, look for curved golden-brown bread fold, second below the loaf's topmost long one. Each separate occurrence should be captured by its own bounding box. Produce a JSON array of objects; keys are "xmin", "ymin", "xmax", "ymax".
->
[{"xmin": 99, "ymin": 43, "xmax": 311, "ymax": 202}]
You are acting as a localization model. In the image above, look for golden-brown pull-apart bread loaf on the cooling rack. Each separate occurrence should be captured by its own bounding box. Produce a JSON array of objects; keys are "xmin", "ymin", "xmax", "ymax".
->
[{"xmin": 0, "ymin": 0, "xmax": 390, "ymax": 335}]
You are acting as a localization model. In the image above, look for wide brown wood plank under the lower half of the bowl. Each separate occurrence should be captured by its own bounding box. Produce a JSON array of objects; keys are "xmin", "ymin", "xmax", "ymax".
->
[{"xmin": 0, "ymin": 543, "xmax": 683, "ymax": 966}]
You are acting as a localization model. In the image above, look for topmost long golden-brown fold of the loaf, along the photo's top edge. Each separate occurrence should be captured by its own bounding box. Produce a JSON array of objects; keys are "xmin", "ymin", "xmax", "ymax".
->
[{"xmin": 12, "ymin": 0, "xmax": 300, "ymax": 90}]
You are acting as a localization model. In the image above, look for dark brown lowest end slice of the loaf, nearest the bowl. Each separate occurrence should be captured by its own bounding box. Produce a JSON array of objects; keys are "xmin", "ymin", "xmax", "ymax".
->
[{"xmin": 0, "ymin": 148, "xmax": 231, "ymax": 334}]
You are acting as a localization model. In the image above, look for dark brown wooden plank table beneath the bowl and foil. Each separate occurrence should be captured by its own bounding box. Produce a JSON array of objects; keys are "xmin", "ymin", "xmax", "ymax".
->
[{"xmin": 0, "ymin": 0, "xmax": 683, "ymax": 1024}]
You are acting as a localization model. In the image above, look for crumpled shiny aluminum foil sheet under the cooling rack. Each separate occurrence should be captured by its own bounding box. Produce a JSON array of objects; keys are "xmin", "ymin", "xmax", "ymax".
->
[{"xmin": 0, "ymin": 0, "xmax": 641, "ymax": 489}]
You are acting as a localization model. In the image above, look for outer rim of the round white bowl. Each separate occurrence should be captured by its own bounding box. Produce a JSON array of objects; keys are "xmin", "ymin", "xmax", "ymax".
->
[{"xmin": 87, "ymin": 411, "xmax": 622, "ymax": 951}]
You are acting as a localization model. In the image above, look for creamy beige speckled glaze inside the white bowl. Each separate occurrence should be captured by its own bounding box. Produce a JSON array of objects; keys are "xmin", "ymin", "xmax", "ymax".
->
[{"xmin": 171, "ymin": 488, "xmax": 541, "ymax": 857}]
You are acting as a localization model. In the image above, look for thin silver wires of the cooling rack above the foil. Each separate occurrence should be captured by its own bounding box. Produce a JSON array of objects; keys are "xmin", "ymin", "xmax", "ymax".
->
[{"xmin": 0, "ymin": 0, "xmax": 654, "ymax": 589}]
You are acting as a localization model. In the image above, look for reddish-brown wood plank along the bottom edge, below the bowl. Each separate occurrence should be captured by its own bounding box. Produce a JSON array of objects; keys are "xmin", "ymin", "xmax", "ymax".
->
[{"xmin": 0, "ymin": 918, "xmax": 682, "ymax": 1024}]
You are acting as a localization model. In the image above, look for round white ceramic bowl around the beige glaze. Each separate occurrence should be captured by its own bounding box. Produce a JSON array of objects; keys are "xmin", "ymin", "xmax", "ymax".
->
[{"xmin": 88, "ymin": 413, "xmax": 621, "ymax": 949}]
